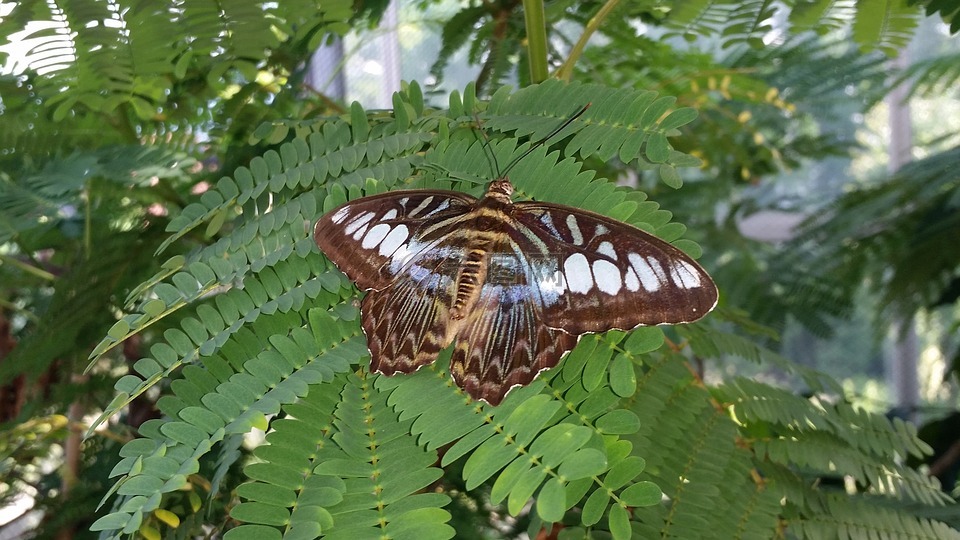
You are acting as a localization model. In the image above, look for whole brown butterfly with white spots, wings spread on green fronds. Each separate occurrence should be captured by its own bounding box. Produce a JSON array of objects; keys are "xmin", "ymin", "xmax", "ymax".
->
[{"xmin": 314, "ymin": 113, "xmax": 717, "ymax": 405}]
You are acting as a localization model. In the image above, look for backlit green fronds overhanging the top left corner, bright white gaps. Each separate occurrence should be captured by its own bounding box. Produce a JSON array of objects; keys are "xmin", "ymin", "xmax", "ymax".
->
[{"xmin": 3, "ymin": 0, "xmax": 352, "ymax": 119}]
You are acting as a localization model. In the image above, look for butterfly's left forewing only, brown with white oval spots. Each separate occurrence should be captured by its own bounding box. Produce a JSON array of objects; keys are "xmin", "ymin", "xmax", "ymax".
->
[{"xmin": 313, "ymin": 190, "xmax": 477, "ymax": 290}]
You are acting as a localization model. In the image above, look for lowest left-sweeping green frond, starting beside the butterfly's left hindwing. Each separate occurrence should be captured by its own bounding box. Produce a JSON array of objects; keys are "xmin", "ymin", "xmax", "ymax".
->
[{"xmin": 92, "ymin": 310, "xmax": 365, "ymax": 533}]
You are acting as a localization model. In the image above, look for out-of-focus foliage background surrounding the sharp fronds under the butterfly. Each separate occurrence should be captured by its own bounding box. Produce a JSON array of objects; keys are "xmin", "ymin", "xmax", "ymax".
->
[{"xmin": 0, "ymin": 0, "xmax": 960, "ymax": 538}]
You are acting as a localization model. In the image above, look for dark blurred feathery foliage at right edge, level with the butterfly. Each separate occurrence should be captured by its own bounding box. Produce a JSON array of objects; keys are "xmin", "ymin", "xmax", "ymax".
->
[{"xmin": 788, "ymin": 143, "xmax": 960, "ymax": 321}]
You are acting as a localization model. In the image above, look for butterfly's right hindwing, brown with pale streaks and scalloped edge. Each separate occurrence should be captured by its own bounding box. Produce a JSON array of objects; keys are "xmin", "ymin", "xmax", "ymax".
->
[{"xmin": 450, "ymin": 239, "xmax": 578, "ymax": 405}]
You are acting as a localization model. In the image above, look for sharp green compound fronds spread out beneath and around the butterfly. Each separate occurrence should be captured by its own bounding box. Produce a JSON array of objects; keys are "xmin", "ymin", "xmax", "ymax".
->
[{"xmin": 73, "ymin": 82, "xmax": 953, "ymax": 538}]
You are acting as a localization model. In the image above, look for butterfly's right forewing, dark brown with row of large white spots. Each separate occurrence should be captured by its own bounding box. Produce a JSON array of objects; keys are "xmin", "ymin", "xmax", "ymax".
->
[{"xmin": 513, "ymin": 202, "xmax": 717, "ymax": 334}]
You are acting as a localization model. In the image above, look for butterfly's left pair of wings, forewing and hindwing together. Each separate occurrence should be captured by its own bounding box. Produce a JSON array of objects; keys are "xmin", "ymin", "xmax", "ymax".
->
[{"xmin": 314, "ymin": 190, "xmax": 476, "ymax": 375}]
